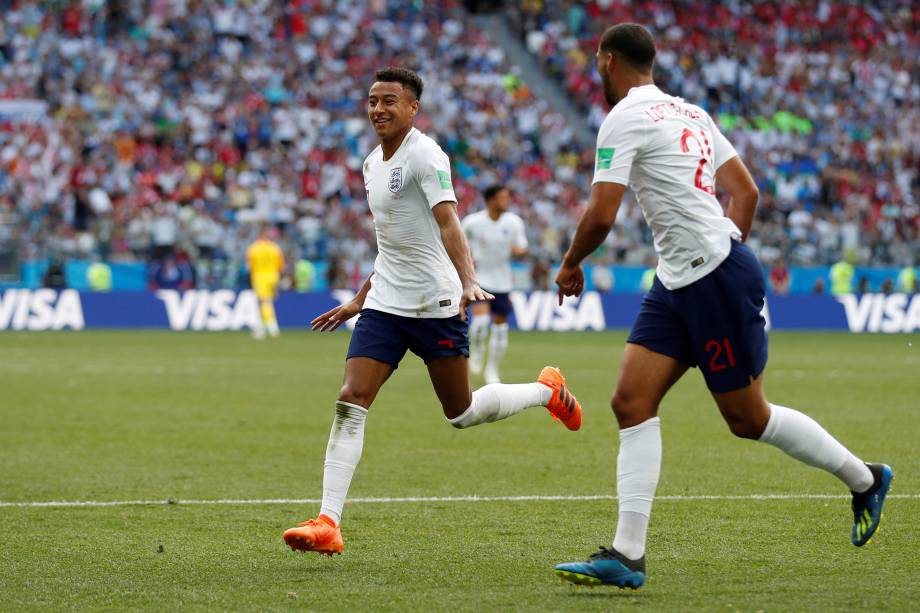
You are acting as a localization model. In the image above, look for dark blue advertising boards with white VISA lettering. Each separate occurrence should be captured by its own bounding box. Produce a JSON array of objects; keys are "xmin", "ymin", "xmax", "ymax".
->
[{"xmin": 0, "ymin": 289, "xmax": 920, "ymax": 333}]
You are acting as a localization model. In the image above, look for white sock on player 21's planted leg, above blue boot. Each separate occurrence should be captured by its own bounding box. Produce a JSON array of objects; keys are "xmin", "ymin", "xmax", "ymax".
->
[{"xmin": 613, "ymin": 417, "xmax": 661, "ymax": 560}]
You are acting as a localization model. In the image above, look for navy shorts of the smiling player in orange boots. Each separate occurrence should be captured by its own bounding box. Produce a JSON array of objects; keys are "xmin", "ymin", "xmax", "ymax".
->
[{"xmin": 346, "ymin": 309, "xmax": 470, "ymax": 368}]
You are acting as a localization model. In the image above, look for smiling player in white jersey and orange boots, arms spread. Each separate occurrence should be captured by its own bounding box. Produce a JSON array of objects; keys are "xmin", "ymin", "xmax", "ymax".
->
[{"xmin": 283, "ymin": 68, "xmax": 581, "ymax": 555}]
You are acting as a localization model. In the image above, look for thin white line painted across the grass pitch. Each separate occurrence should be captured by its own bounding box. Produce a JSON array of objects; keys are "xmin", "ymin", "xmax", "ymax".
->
[{"xmin": 0, "ymin": 494, "xmax": 920, "ymax": 508}]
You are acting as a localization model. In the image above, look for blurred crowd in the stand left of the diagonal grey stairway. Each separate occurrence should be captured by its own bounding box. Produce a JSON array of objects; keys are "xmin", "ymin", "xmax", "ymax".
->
[{"xmin": 0, "ymin": 0, "xmax": 591, "ymax": 285}]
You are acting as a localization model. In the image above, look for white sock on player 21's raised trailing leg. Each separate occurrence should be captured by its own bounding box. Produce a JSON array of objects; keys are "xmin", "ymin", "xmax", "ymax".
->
[{"xmin": 760, "ymin": 404, "xmax": 874, "ymax": 492}]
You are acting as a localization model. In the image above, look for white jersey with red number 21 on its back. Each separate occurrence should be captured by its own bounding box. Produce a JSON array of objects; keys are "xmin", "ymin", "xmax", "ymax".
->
[{"xmin": 594, "ymin": 85, "xmax": 741, "ymax": 290}]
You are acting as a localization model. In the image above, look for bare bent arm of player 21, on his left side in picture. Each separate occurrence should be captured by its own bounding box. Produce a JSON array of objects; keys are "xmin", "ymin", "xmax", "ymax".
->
[{"xmin": 556, "ymin": 182, "xmax": 626, "ymax": 305}]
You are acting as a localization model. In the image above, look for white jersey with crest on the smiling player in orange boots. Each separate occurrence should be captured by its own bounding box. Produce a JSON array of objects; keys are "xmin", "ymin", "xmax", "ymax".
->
[{"xmin": 364, "ymin": 128, "xmax": 461, "ymax": 318}]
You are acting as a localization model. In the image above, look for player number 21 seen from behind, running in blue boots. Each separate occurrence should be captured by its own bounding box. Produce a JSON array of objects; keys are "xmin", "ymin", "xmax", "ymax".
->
[{"xmin": 556, "ymin": 24, "xmax": 892, "ymax": 588}]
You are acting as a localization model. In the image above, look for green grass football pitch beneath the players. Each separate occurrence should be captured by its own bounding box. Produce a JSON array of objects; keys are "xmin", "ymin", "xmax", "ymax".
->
[{"xmin": 0, "ymin": 332, "xmax": 920, "ymax": 611}]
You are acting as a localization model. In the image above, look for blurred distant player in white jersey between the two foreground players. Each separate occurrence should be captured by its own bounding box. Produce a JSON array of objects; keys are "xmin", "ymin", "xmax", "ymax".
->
[{"xmin": 461, "ymin": 185, "xmax": 527, "ymax": 383}]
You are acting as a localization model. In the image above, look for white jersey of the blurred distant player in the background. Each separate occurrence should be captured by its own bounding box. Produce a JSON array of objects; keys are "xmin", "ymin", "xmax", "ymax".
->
[{"xmin": 462, "ymin": 211, "xmax": 527, "ymax": 294}]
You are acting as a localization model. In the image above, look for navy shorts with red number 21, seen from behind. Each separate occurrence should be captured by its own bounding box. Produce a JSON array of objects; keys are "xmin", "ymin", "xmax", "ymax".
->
[{"xmin": 626, "ymin": 240, "xmax": 767, "ymax": 393}]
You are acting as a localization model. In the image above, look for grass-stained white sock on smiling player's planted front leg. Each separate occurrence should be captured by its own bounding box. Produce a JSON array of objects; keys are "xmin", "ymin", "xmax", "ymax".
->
[{"xmin": 319, "ymin": 401, "xmax": 367, "ymax": 524}]
